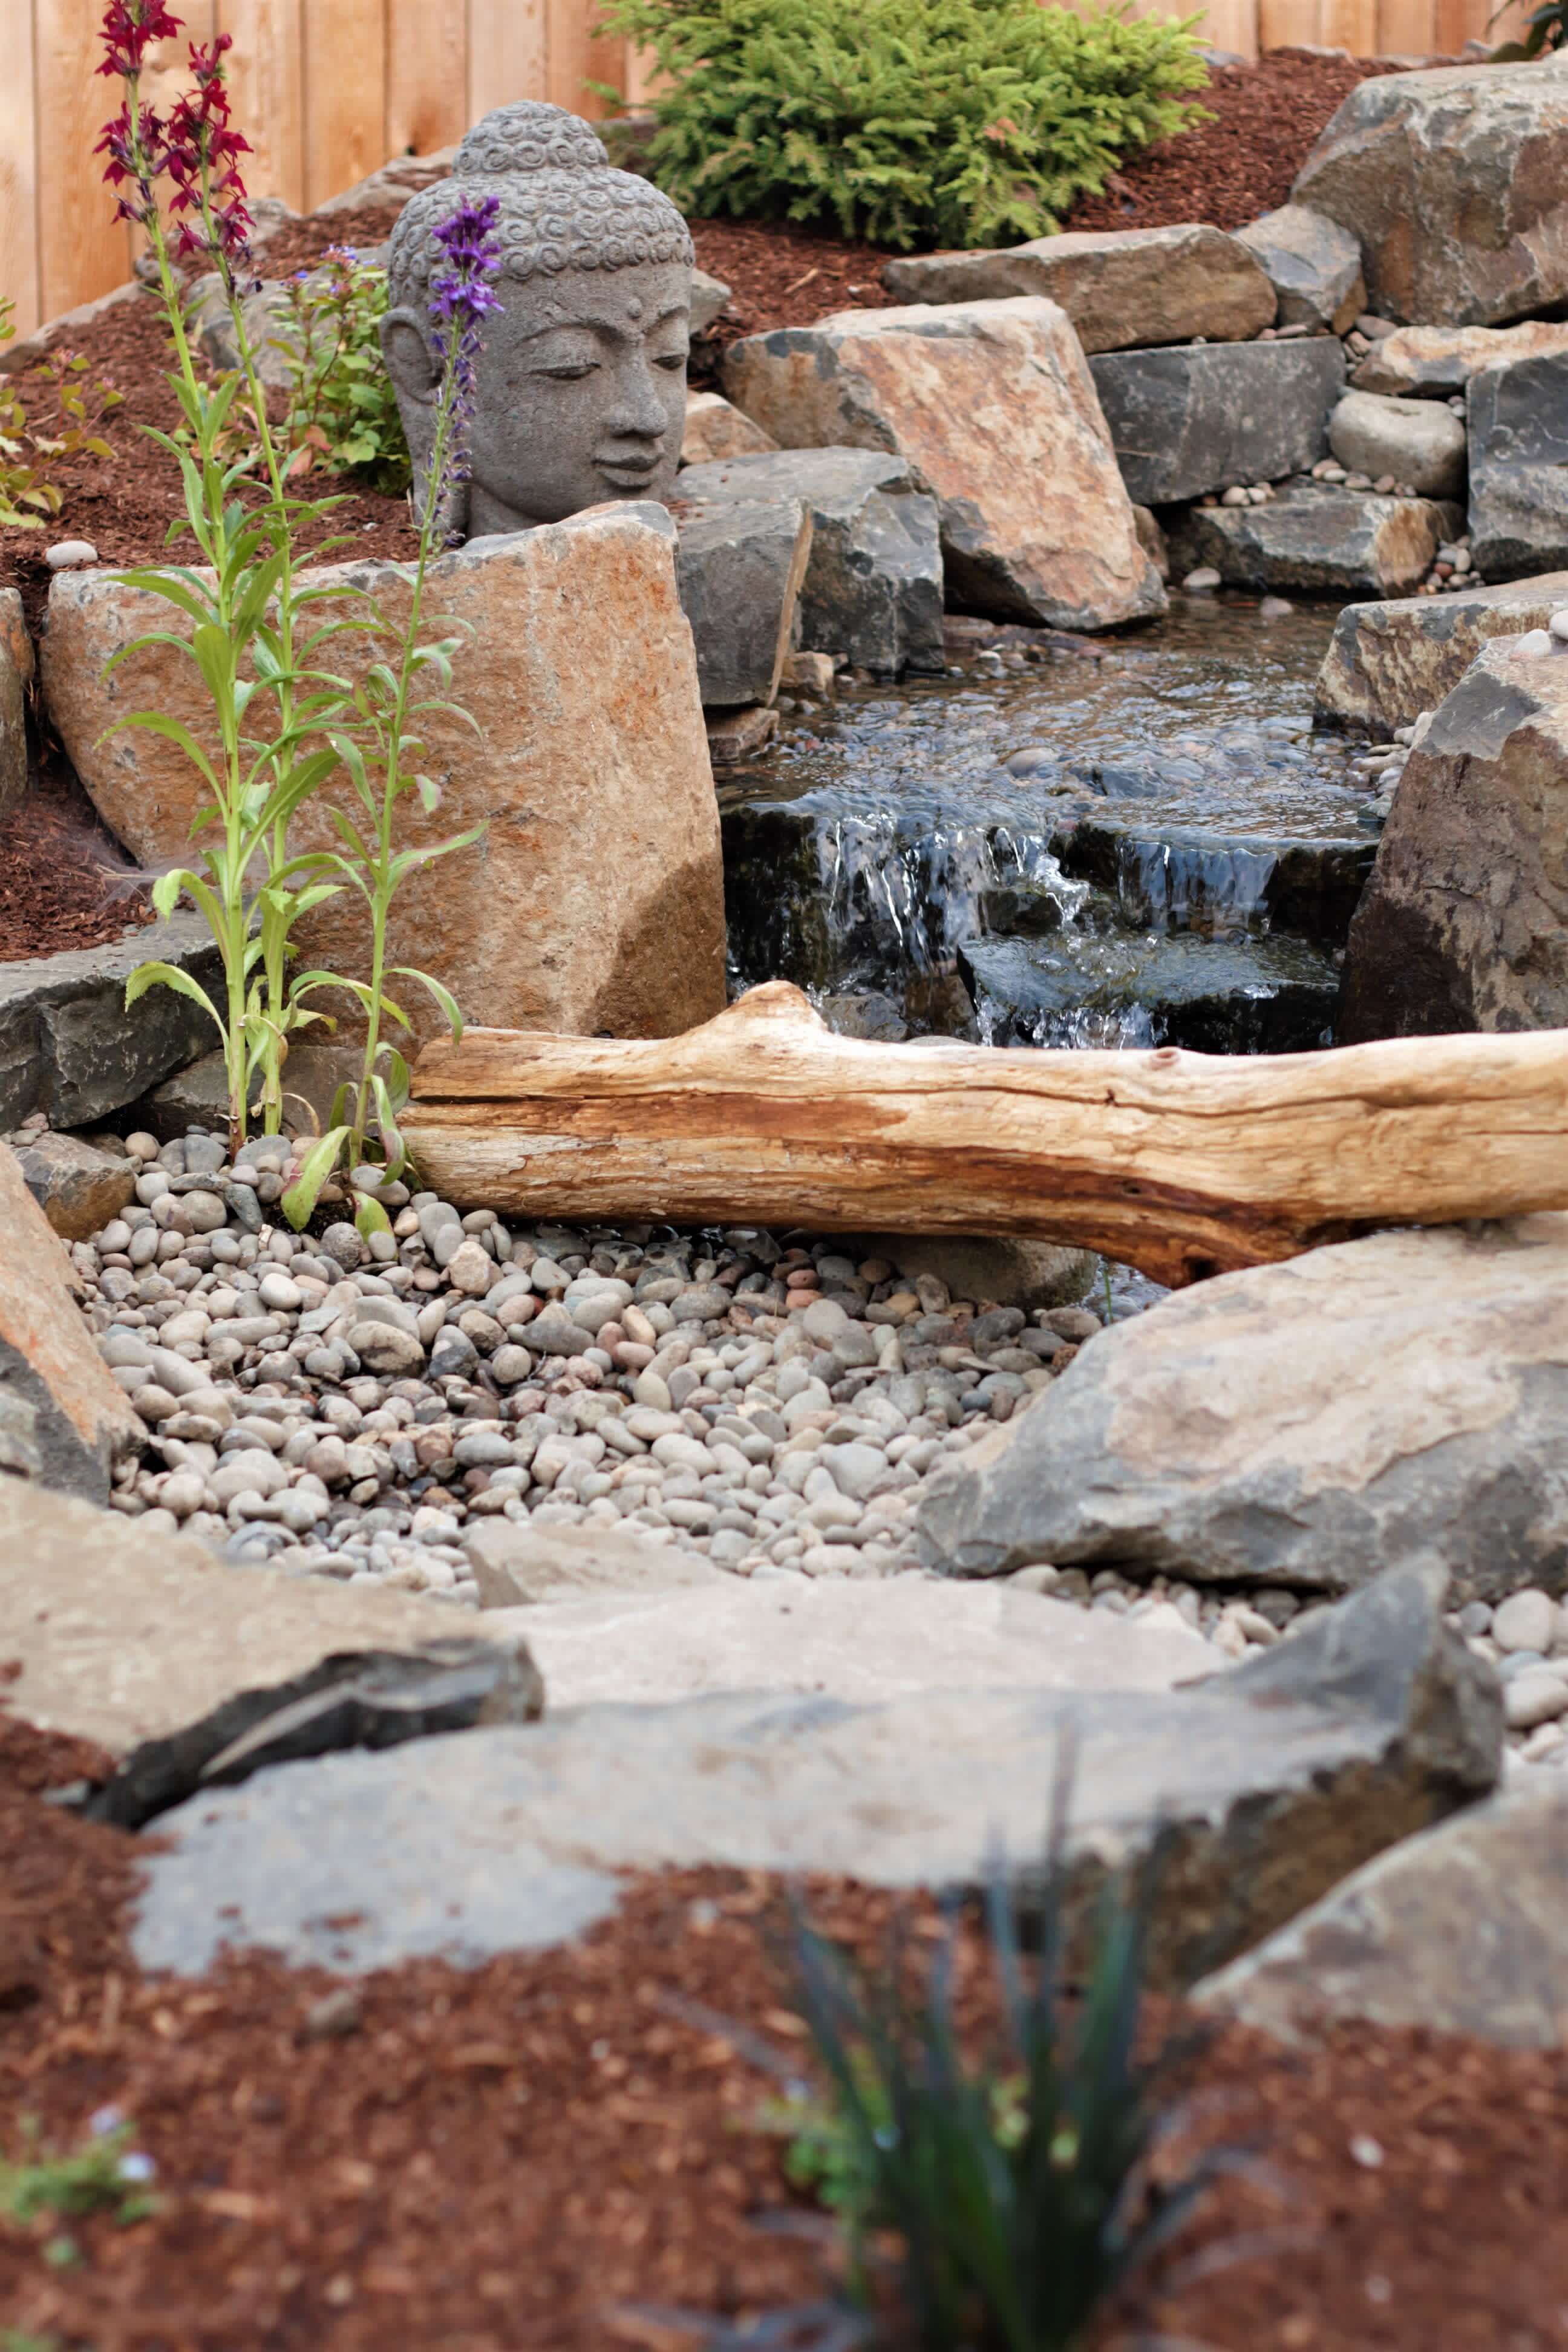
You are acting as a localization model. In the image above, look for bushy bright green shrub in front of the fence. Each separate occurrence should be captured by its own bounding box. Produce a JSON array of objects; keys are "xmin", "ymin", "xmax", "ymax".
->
[{"xmin": 604, "ymin": 0, "xmax": 1208, "ymax": 247}]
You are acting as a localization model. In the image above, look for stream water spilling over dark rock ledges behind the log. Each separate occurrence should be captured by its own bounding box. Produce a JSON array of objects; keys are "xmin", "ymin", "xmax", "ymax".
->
[{"xmin": 719, "ymin": 595, "xmax": 1380, "ymax": 1054}]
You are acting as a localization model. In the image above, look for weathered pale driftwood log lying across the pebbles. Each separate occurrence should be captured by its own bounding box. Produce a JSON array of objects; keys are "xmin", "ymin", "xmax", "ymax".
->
[{"xmin": 402, "ymin": 981, "xmax": 1568, "ymax": 1284}]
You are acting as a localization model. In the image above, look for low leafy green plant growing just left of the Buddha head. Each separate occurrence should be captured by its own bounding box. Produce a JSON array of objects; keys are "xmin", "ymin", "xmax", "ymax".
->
[{"xmin": 275, "ymin": 244, "xmax": 411, "ymax": 496}]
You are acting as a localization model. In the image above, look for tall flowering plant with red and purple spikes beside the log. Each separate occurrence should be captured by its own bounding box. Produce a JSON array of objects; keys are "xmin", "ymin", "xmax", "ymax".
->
[{"xmin": 99, "ymin": 0, "xmax": 494, "ymax": 1230}]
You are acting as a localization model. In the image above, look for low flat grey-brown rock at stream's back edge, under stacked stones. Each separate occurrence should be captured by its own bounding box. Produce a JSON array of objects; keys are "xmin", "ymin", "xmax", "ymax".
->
[{"xmin": 1175, "ymin": 482, "xmax": 1462, "ymax": 598}]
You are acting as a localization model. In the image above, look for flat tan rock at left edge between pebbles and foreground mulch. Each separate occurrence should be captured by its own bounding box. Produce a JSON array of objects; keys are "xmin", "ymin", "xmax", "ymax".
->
[{"xmin": 0, "ymin": 1480, "xmax": 526, "ymax": 1754}]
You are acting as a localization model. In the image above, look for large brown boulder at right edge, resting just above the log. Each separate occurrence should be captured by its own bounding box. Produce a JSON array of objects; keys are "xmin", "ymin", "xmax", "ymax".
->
[{"xmin": 1340, "ymin": 638, "xmax": 1568, "ymax": 1044}]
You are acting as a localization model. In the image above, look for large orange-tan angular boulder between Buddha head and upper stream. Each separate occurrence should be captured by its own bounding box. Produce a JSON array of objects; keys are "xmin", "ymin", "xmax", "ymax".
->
[{"xmin": 724, "ymin": 296, "xmax": 1166, "ymax": 628}]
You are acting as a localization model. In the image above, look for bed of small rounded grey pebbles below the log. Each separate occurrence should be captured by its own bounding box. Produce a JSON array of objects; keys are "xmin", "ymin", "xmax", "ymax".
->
[{"xmin": 55, "ymin": 1131, "xmax": 1568, "ymax": 1762}]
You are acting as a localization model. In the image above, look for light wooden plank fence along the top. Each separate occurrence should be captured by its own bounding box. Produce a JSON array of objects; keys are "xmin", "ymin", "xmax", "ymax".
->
[{"xmin": 0, "ymin": 0, "xmax": 1532, "ymax": 334}]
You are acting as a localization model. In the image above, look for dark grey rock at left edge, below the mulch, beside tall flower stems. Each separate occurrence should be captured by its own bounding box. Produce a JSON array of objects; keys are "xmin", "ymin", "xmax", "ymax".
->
[{"xmin": 0, "ymin": 915, "xmax": 218, "ymax": 1126}]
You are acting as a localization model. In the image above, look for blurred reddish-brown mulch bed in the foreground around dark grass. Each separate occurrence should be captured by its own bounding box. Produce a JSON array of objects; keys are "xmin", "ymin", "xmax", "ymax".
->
[{"xmin": 0, "ymin": 1717, "xmax": 1568, "ymax": 2352}]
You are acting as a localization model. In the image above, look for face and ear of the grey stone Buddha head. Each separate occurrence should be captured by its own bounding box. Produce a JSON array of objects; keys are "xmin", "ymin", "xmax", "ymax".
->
[{"xmin": 383, "ymin": 261, "xmax": 691, "ymax": 538}]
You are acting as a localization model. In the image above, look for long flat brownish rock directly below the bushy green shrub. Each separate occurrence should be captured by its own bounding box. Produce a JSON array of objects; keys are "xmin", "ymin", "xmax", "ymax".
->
[{"xmin": 881, "ymin": 221, "xmax": 1274, "ymax": 350}]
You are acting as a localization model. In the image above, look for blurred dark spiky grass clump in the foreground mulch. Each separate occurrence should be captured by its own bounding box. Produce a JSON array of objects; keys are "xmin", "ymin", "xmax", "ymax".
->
[{"xmin": 766, "ymin": 1837, "xmax": 1229, "ymax": 2352}]
